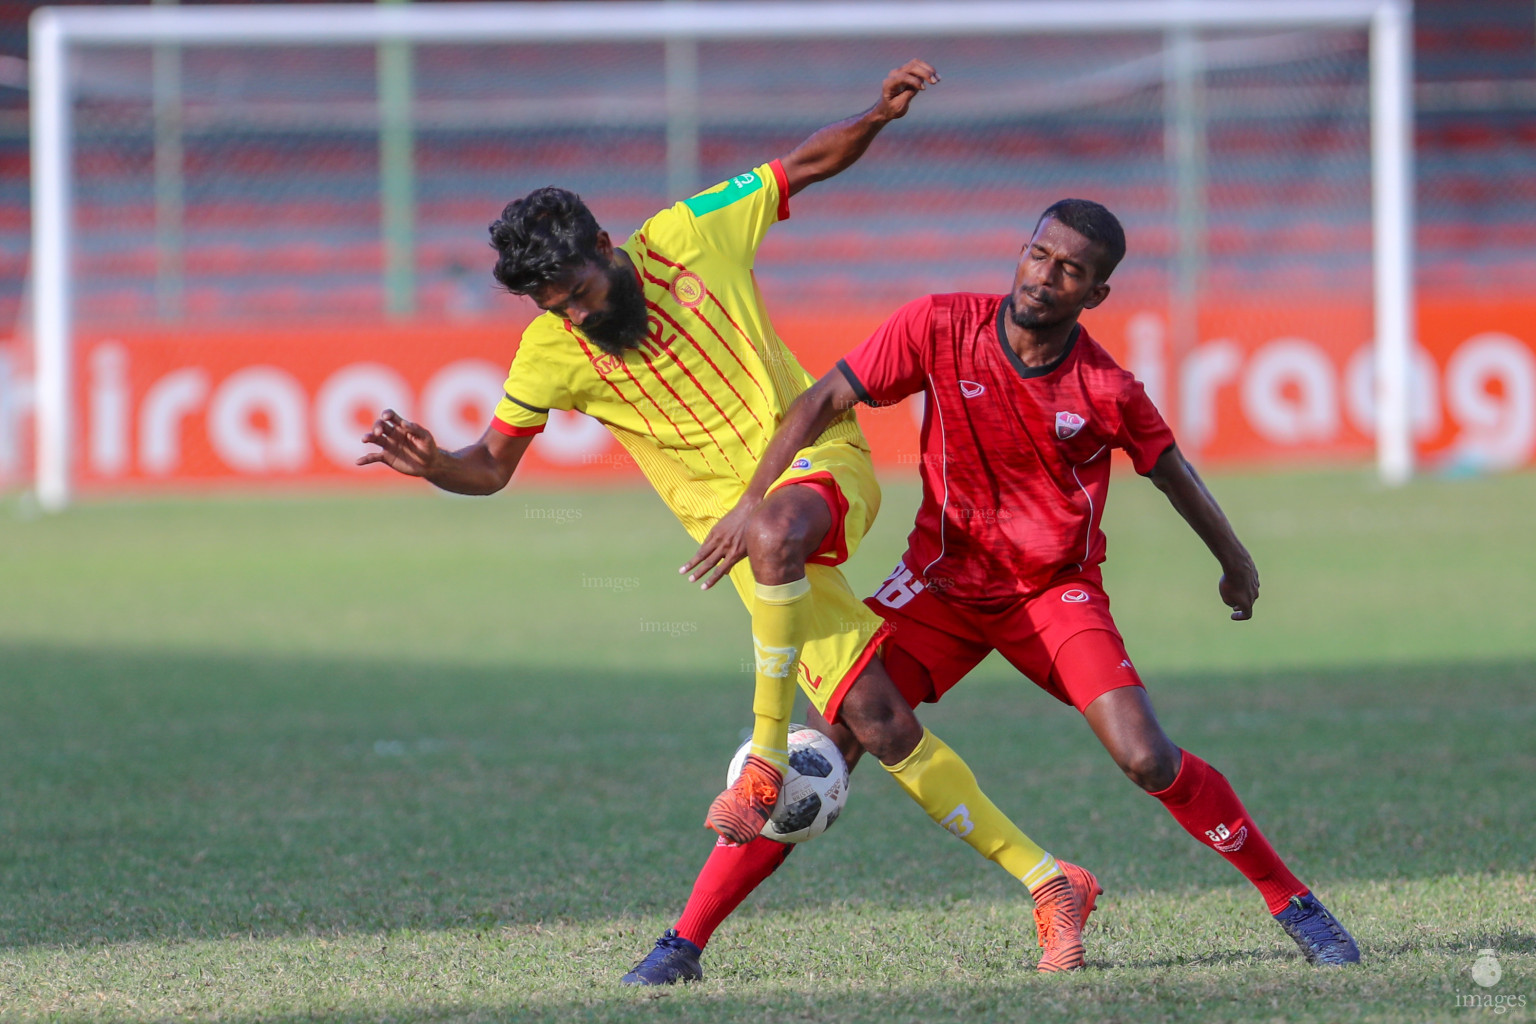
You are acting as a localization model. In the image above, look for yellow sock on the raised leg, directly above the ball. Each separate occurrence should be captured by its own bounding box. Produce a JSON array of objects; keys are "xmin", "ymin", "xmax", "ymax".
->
[{"xmin": 751, "ymin": 576, "xmax": 811, "ymax": 771}]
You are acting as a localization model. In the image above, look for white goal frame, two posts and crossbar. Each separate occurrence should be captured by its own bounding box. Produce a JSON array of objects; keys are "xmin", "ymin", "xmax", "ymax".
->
[{"xmin": 31, "ymin": 0, "xmax": 1415, "ymax": 510}]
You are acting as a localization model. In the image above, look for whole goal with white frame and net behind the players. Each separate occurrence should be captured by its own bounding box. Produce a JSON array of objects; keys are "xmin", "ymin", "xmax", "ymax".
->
[{"xmin": 14, "ymin": 0, "xmax": 1413, "ymax": 507}]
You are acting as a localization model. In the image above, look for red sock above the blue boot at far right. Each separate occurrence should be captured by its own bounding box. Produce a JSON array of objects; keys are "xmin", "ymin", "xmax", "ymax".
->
[{"xmin": 1152, "ymin": 751, "xmax": 1307, "ymax": 913}]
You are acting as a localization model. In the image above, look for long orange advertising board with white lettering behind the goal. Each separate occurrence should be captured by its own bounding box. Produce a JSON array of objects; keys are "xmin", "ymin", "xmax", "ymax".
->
[{"xmin": 0, "ymin": 302, "xmax": 1536, "ymax": 493}]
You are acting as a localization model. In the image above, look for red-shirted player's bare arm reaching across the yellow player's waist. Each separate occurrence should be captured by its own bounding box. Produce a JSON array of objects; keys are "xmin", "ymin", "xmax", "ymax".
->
[{"xmin": 677, "ymin": 367, "xmax": 859, "ymax": 590}]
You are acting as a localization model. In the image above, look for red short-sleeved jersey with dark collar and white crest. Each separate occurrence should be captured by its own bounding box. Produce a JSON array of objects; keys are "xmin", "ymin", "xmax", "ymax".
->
[{"xmin": 837, "ymin": 293, "xmax": 1174, "ymax": 606}]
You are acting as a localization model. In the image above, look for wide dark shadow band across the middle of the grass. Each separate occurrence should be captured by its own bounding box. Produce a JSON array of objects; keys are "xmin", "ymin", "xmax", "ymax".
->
[{"xmin": 0, "ymin": 646, "xmax": 1536, "ymax": 955}]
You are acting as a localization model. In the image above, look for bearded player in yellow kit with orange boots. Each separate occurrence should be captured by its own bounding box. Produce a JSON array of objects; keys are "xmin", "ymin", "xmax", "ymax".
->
[{"xmin": 358, "ymin": 60, "xmax": 1092, "ymax": 981}]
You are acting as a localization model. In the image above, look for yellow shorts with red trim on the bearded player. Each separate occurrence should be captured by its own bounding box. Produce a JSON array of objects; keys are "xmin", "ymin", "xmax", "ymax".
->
[{"xmin": 731, "ymin": 441, "xmax": 889, "ymax": 722}]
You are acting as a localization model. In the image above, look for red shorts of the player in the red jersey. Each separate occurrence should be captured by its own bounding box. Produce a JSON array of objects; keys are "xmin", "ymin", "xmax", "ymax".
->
[{"xmin": 865, "ymin": 562, "xmax": 1141, "ymax": 711}]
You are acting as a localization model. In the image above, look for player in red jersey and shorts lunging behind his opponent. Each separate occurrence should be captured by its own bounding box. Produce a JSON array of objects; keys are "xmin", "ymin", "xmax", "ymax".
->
[{"xmin": 663, "ymin": 200, "xmax": 1359, "ymax": 964}]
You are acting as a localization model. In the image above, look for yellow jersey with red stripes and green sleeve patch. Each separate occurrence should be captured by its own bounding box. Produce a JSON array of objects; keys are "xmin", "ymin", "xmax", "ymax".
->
[{"xmin": 492, "ymin": 160, "xmax": 868, "ymax": 539}]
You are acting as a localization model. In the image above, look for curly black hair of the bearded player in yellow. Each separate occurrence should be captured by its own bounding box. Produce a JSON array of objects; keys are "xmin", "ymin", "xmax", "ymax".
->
[{"xmin": 490, "ymin": 186, "xmax": 599, "ymax": 295}]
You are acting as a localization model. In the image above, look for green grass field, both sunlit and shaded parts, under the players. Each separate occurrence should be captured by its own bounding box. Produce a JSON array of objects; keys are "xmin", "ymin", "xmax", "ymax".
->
[{"xmin": 0, "ymin": 473, "xmax": 1536, "ymax": 1024}]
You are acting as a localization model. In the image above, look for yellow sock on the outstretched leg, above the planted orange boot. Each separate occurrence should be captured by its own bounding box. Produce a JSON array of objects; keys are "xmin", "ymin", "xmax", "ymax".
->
[{"xmin": 885, "ymin": 729, "xmax": 1061, "ymax": 892}]
